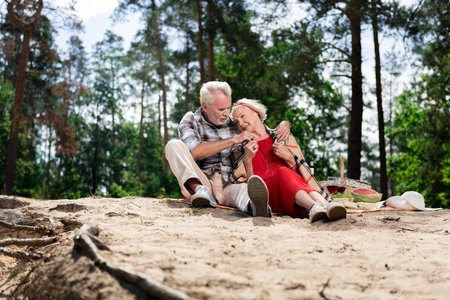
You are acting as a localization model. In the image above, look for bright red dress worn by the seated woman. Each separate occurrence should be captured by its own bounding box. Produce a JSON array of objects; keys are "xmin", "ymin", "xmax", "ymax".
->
[{"xmin": 252, "ymin": 136, "xmax": 315, "ymax": 218}]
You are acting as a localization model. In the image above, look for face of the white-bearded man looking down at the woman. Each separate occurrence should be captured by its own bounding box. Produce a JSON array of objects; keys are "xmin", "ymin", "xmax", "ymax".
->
[{"xmin": 202, "ymin": 91, "xmax": 231, "ymax": 126}]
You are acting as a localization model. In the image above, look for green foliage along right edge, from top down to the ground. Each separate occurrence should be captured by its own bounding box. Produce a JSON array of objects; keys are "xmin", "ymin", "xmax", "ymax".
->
[{"xmin": 388, "ymin": 0, "xmax": 450, "ymax": 208}]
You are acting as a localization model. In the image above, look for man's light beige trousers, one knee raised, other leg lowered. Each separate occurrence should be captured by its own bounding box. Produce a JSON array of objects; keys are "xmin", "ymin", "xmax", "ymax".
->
[{"xmin": 164, "ymin": 140, "xmax": 250, "ymax": 212}]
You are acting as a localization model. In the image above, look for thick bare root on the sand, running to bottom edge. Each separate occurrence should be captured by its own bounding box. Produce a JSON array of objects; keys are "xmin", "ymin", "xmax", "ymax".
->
[{"xmin": 74, "ymin": 224, "xmax": 194, "ymax": 300}]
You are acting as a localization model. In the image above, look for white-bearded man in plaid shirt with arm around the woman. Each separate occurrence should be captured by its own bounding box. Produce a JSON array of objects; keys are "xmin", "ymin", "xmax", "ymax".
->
[{"xmin": 165, "ymin": 81, "xmax": 290, "ymax": 217}]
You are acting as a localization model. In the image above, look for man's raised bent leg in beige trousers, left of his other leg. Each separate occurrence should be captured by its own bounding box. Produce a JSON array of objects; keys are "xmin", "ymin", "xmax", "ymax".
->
[{"xmin": 164, "ymin": 140, "xmax": 217, "ymax": 206}]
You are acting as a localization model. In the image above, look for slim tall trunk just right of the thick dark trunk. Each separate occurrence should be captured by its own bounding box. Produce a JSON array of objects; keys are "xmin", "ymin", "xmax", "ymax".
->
[{"xmin": 372, "ymin": 0, "xmax": 388, "ymax": 199}]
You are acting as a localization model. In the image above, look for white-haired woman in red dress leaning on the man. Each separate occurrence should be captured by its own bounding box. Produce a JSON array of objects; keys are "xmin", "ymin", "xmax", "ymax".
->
[{"xmin": 232, "ymin": 99, "xmax": 346, "ymax": 222}]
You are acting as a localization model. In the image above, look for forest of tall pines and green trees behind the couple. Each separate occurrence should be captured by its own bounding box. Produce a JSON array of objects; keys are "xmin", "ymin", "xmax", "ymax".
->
[{"xmin": 0, "ymin": 0, "xmax": 450, "ymax": 208}]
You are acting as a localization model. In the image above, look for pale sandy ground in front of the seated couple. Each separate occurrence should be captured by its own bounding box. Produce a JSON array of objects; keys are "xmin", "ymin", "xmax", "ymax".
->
[{"xmin": 0, "ymin": 196, "xmax": 450, "ymax": 299}]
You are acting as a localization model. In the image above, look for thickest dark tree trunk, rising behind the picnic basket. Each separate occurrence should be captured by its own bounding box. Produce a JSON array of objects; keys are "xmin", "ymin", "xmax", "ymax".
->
[{"xmin": 347, "ymin": 4, "xmax": 363, "ymax": 179}]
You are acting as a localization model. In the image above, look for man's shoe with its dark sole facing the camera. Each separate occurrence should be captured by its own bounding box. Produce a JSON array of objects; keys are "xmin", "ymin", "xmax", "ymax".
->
[{"xmin": 247, "ymin": 175, "xmax": 272, "ymax": 217}]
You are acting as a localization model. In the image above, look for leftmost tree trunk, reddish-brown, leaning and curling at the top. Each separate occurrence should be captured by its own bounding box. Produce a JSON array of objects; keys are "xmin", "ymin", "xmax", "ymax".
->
[{"xmin": 5, "ymin": 0, "xmax": 43, "ymax": 195}]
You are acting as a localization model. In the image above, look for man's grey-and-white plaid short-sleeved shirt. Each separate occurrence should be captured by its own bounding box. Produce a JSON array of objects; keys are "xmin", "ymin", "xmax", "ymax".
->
[{"xmin": 178, "ymin": 107, "xmax": 240, "ymax": 182}]
